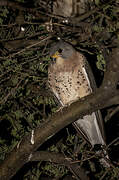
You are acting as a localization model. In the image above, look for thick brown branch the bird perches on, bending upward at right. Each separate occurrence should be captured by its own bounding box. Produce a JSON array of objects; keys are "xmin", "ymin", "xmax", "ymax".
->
[{"xmin": 0, "ymin": 48, "xmax": 119, "ymax": 180}]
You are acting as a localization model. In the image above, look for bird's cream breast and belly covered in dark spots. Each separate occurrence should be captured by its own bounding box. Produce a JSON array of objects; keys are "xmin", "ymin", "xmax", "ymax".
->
[{"xmin": 49, "ymin": 68, "xmax": 91, "ymax": 105}]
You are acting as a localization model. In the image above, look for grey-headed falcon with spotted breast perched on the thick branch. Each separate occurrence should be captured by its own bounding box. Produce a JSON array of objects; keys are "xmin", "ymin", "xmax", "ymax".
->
[{"xmin": 48, "ymin": 41, "xmax": 109, "ymax": 167}]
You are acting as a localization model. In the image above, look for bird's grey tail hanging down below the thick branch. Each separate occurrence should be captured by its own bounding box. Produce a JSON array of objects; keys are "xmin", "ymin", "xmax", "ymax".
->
[{"xmin": 74, "ymin": 111, "xmax": 110, "ymax": 167}]
